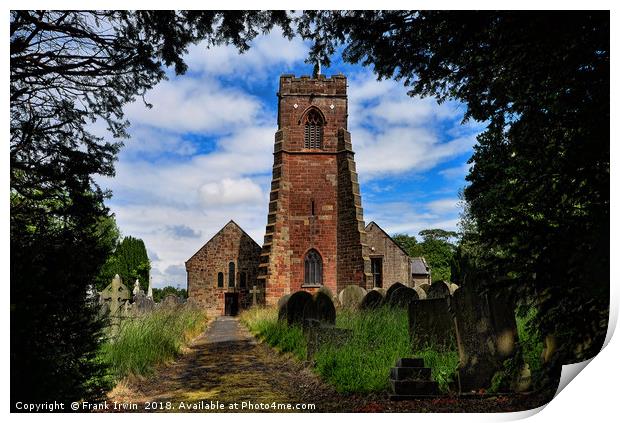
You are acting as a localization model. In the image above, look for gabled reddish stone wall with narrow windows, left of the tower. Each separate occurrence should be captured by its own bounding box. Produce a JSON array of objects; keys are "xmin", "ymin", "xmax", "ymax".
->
[{"xmin": 185, "ymin": 220, "xmax": 261, "ymax": 316}]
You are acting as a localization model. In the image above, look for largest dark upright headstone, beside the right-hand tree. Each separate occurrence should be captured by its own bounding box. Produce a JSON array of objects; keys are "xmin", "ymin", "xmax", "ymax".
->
[{"xmin": 452, "ymin": 286, "xmax": 517, "ymax": 391}]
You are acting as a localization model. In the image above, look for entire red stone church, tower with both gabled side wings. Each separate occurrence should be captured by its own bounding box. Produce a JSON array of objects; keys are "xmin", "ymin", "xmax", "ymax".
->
[{"xmin": 185, "ymin": 75, "xmax": 426, "ymax": 315}]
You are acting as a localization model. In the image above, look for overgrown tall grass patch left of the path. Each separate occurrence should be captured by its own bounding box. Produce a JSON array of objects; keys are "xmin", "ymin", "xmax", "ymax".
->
[{"xmin": 99, "ymin": 306, "xmax": 207, "ymax": 380}]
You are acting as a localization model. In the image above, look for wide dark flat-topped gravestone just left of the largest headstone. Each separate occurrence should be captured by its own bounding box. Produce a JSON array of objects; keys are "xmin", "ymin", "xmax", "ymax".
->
[{"xmin": 408, "ymin": 298, "xmax": 456, "ymax": 349}]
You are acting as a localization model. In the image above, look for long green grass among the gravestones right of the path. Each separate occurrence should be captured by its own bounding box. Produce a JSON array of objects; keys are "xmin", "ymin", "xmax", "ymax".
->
[{"xmin": 241, "ymin": 307, "xmax": 458, "ymax": 393}]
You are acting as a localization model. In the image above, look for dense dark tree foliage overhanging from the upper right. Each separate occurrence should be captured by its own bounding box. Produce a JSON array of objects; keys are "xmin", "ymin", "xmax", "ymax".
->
[{"xmin": 299, "ymin": 11, "xmax": 610, "ymax": 361}]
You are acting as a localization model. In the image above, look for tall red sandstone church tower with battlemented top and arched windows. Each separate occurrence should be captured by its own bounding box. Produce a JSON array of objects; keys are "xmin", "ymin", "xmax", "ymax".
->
[{"xmin": 258, "ymin": 75, "xmax": 372, "ymax": 305}]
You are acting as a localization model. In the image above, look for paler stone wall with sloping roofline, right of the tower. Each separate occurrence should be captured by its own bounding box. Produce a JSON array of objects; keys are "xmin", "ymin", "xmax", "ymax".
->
[{"xmin": 366, "ymin": 222, "xmax": 414, "ymax": 289}]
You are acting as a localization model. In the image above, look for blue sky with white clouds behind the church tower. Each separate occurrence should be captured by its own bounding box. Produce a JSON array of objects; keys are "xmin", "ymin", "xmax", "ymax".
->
[{"xmin": 95, "ymin": 31, "xmax": 482, "ymax": 287}]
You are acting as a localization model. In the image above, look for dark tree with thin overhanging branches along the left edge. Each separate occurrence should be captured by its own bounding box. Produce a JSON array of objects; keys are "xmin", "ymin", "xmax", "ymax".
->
[{"xmin": 10, "ymin": 10, "xmax": 290, "ymax": 404}]
